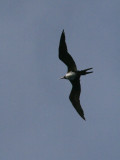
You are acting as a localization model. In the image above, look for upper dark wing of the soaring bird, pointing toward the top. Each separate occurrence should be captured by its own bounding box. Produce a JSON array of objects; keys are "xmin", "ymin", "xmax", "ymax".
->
[{"xmin": 59, "ymin": 30, "xmax": 77, "ymax": 72}]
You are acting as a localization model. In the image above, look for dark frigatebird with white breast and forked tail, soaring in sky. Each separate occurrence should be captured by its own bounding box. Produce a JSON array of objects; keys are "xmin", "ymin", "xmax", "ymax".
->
[{"xmin": 58, "ymin": 30, "xmax": 93, "ymax": 120}]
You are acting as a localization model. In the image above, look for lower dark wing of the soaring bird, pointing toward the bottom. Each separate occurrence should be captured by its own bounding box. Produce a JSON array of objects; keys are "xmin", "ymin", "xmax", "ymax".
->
[{"xmin": 69, "ymin": 79, "xmax": 85, "ymax": 120}]
